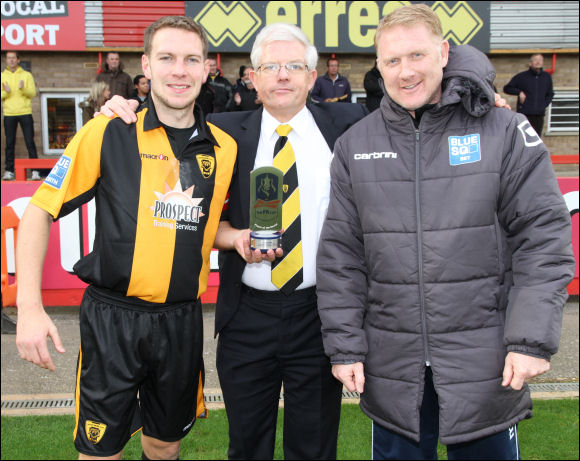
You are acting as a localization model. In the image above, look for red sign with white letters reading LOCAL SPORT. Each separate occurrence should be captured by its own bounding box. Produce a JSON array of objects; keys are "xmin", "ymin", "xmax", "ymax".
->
[{"xmin": 1, "ymin": 0, "xmax": 86, "ymax": 51}]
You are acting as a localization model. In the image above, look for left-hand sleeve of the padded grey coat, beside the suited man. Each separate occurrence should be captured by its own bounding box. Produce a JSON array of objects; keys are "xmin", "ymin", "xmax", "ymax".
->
[{"xmin": 316, "ymin": 138, "xmax": 368, "ymax": 363}]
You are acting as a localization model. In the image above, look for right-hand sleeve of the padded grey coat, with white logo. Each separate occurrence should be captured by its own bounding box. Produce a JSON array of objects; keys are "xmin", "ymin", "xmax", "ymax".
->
[{"xmin": 498, "ymin": 114, "xmax": 575, "ymax": 360}]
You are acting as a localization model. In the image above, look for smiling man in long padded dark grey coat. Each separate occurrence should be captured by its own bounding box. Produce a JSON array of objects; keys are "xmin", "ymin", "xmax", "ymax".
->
[{"xmin": 317, "ymin": 5, "xmax": 574, "ymax": 459}]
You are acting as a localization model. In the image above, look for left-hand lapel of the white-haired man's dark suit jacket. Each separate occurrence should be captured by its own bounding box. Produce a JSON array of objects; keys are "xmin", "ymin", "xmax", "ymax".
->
[{"xmin": 237, "ymin": 109, "xmax": 262, "ymax": 224}]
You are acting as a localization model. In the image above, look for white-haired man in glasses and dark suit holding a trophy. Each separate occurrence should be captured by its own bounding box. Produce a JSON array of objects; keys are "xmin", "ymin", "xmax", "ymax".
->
[{"xmin": 211, "ymin": 24, "xmax": 367, "ymax": 459}]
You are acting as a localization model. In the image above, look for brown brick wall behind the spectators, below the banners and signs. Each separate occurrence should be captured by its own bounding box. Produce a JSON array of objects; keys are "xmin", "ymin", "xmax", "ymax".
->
[{"xmin": 1, "ymin": 48, "xmax": 579, "ymax": 172}]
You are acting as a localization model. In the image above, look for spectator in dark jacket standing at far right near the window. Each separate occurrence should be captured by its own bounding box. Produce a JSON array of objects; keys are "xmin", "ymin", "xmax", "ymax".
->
[{"xmin": 503, "ymin": 54, "xmax": 554, "ymax": 136}]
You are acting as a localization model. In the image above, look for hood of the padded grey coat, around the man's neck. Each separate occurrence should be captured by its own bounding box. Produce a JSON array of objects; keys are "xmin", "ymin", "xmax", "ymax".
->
[{"xmin": 379, "ymin": 45, "xmax": 495, "ymax": 121}]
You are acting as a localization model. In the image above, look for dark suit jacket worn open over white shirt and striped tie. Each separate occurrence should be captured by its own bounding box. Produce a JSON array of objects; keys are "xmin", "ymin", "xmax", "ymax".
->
[{"xmin": 207, "ymin": 103, "xmax": 368, "ymax": 336}]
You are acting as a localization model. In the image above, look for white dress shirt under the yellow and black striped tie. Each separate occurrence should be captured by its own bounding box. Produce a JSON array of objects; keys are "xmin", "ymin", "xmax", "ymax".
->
[{"xmin": 242, "ymin": 106, "xmax": 332, "ymax": 291}]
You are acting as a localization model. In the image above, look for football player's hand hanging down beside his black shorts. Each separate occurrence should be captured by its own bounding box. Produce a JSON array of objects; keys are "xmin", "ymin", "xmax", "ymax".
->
[{"xmin": 16, "ymin": 308, "xmax": 66, "ymax": 371}]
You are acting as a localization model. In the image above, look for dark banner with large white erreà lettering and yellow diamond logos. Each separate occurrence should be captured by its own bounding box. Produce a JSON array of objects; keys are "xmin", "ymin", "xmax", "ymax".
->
[{"xmin": 185, "ymin": 1, "xmax": 490, "ymax": 53}]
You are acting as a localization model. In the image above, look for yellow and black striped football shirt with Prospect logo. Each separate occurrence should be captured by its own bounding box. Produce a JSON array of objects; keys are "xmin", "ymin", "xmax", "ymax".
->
[{"xmin": 31, "ymin": 102, "xmax": 237, "ymax": 303}]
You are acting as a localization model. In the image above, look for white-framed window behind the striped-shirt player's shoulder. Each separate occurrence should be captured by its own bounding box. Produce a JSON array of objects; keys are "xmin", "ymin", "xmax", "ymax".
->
[{"xmin": 41, "ymin": 93, "xmax": 88, "ymax": 155}]
